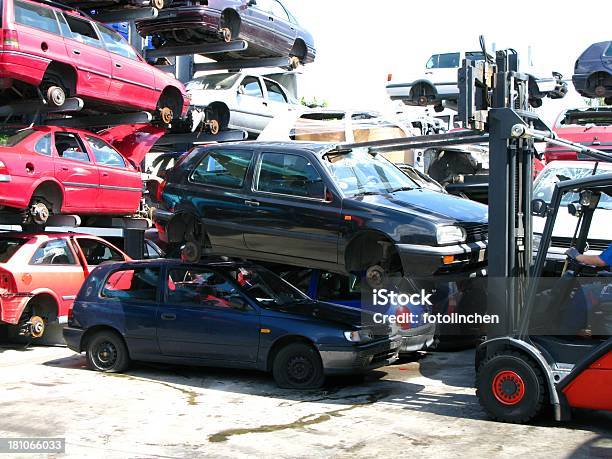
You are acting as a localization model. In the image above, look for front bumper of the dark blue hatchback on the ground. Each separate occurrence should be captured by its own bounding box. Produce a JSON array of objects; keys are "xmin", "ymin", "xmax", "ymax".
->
[{"xmin": 319, "ymin": 335, "xmax": 403, "ymax": 375}]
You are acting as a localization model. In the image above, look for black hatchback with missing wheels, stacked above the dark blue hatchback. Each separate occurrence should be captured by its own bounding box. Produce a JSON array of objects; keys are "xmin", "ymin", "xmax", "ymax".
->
[{"xmin": 154, "ymin": 142, "xmax": 488, "ymax": 286}]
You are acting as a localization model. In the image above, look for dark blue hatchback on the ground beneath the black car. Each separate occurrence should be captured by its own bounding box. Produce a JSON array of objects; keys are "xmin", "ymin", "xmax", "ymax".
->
[{"xmin": 64, "ymin": 260, "xmax": 401, "ymax": 389}]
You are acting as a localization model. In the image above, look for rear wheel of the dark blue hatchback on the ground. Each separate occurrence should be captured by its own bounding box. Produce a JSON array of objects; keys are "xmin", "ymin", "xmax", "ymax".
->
[{"xmin": 85, "ymin": 331, "xmax": 130, "ymax": 373}]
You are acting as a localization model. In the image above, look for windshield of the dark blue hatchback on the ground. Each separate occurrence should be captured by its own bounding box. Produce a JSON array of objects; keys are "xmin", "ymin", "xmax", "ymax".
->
[{"xmin": 225, "ymin": 267, "xmax": 312, "ymax": 309}]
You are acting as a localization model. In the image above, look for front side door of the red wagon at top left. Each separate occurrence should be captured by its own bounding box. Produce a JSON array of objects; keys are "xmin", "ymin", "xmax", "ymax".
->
[{"xmin": 97, "ymin": 24, "xmax": 159, "ymax": 109}]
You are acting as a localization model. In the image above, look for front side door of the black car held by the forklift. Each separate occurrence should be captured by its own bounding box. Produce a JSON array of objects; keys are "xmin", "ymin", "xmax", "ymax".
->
[{"xmin": 244, "ymin": 152, "xmax": 341, "ymax": 263}]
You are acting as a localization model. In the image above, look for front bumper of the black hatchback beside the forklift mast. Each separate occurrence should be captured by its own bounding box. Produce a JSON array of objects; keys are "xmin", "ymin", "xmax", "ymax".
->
[{"xmin": 395, "ymin": 241, "xmax": 487, "ymax": 278}]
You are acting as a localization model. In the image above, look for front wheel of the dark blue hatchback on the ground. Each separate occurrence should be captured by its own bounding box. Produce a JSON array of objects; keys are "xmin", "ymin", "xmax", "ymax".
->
[{"xmin": 272, "ymin": 343, "xmax": 325, "ymax": 389}]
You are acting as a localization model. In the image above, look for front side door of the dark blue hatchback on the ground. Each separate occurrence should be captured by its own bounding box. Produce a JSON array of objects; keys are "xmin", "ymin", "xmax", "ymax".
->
[{"xmin": 157, "ymin": 266, "xmax": 260, "ymax": 363}]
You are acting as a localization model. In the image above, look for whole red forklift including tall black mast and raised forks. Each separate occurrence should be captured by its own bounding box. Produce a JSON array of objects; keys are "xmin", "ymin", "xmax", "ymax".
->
[{"xmin": 342, "ymin": 38, "xmax": 612, "ymax": 422}]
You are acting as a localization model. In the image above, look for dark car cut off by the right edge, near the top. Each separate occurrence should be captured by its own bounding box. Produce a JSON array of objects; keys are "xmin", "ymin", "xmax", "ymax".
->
[{"xmin": 572, "ymin": 41, "xmax": 612, "ymax": 105}]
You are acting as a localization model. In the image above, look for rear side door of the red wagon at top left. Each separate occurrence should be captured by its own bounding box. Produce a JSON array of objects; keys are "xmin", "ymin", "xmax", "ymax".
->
[{"xmin": 58, "ymin": 13, "xmax": 111, "ymax": 103}]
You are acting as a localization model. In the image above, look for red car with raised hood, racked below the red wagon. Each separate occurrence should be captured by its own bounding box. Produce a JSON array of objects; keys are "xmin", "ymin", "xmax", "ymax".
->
[{"xmin": 0, "ymin": 125, "xmax": 165, "ymax": 224}]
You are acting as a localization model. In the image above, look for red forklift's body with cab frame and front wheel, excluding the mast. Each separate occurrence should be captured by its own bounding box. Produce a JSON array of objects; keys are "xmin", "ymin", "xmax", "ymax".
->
[{"xmin": 476, "ymin": 174, "xmax": 612, "ymax": 422}]
